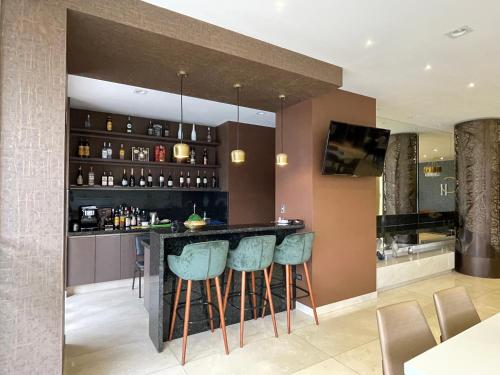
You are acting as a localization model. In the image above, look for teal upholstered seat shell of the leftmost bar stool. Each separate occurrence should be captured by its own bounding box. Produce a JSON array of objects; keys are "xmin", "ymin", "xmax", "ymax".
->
[{"xmin": 167, "ymin": 240, "xmax": 229, "ymax": 280}]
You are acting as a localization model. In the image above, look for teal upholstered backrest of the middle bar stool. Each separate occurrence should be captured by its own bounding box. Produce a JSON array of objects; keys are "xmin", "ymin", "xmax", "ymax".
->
[{"xmin": 230, "ymin": 235, "xmax": 276, "ymax": 272}]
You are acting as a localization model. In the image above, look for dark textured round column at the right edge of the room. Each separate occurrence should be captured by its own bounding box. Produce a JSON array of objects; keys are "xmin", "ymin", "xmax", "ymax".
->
[{"xmin": 455, "ymin": 119, "xmax": 500, "ymax": 278}]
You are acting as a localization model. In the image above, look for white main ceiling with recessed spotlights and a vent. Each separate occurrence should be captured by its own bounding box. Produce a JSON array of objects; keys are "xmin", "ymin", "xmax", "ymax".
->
[{"xmin": 146, "ymin": 0, "xmax": 500, "ymax": 130}]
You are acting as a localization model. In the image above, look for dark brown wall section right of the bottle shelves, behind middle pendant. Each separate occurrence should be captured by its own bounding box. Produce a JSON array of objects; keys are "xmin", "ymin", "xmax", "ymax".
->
[{"xmin": 217, "ymin": 122, "xmax": 275, "ymax": 224}]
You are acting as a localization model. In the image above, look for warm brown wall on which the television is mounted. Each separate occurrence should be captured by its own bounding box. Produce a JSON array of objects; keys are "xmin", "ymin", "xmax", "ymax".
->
[{"xmin": 276, "ymin": 90, "xmax": 377, "ymax": 306}]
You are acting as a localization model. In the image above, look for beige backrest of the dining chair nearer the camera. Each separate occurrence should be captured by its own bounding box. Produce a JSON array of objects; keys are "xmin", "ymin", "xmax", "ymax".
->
[{"xmin": 377, "ymin": 301, "xmax": 436, "ymax": 375}]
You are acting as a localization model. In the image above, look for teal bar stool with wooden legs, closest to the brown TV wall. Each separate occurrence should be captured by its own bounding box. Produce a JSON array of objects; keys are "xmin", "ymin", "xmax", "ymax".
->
[{"xmin": 262, "ymin": 232, "xmax": 319, "ymax": 333}]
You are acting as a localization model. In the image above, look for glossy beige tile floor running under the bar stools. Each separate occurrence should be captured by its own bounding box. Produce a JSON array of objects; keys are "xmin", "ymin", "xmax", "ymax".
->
[{"xmin": 64, "ymin": 272, "xmax": 500, "ymax": 375}]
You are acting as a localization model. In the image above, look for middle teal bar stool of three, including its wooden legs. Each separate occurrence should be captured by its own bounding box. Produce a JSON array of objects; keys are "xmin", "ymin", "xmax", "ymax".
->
[{"xmin": 223, "ymin": 235, "xmax": 278, "ymax": 348}]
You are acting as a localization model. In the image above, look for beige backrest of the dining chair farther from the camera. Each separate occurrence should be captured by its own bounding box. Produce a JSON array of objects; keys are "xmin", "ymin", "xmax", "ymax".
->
[{"xmin": 434, "ymin": 286, "xmax": 481, "ymax": 341}]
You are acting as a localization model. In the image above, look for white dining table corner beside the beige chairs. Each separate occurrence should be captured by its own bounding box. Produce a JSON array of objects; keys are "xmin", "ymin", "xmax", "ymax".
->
[{"xmin": 404, "ymin": 313, "xmax": 500, "ymax": 375}]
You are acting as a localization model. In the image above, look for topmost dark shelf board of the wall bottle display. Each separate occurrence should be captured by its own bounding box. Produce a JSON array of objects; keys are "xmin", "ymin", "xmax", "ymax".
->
[{"xmin": 70, "ymin": 128, "xmax": 219, "ymax": 147}]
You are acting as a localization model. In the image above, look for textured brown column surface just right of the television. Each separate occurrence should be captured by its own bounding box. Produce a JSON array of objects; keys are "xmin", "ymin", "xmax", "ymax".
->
[{"xmin": 383, "ymin": 133, "xmax": 418, "ymax": 215}]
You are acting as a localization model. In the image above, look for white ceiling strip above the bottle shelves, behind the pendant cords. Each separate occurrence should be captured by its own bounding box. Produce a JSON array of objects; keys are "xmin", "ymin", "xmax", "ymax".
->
[{"xmin": 68, "ymin": 75, "xmax": 275, "ymax": 127}]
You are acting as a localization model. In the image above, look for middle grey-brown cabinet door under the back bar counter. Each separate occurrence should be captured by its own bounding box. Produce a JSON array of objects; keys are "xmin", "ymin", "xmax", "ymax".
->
[{"xmin": 95, "ymin": 234, "xmax": 120, "ymax": 283}]
